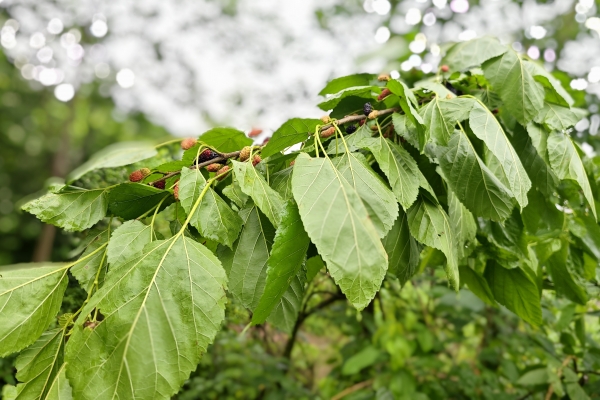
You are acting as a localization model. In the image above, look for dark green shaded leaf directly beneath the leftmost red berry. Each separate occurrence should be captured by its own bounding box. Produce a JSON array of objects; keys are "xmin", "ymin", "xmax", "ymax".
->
[{"xmin": 108, "ymin": 183, "xmax": 174, "ymax": 220}]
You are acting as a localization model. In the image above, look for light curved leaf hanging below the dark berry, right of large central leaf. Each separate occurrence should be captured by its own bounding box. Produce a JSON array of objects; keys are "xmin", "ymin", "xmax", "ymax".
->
[{"xmin": 360, "ymin": 136, "xmax": 421, "ymax": 210}]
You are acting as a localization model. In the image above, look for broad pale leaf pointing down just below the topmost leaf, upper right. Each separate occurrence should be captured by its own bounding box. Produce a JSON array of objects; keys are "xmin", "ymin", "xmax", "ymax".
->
[{"xmin": 483, "ymin": 49, "xmax": 544, "ymax": 125}]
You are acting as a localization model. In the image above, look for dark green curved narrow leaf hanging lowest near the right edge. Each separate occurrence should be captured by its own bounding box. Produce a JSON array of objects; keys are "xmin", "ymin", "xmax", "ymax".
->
[{"xmin": 546, "ymin": 240, "xmax": 589, "ymax": 305}]
